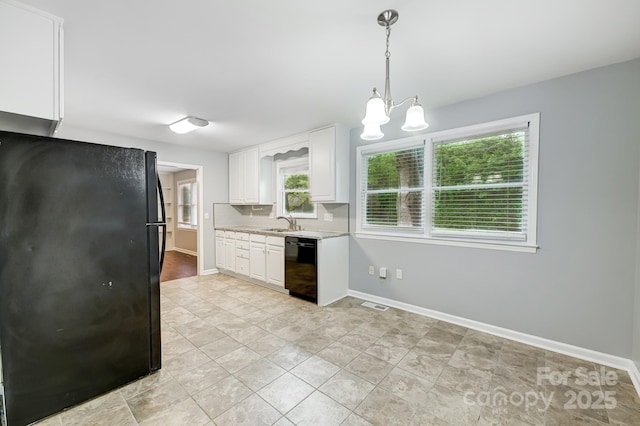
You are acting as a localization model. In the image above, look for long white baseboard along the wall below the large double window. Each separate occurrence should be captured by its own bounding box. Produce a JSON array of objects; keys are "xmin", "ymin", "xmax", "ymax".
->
[{"xmin": 348, "ymin": 290, "xmax": 640, "ymax": 396}]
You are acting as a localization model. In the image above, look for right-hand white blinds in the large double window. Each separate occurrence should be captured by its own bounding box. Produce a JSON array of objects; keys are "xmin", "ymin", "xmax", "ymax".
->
[{"xmin": 431, "ymin": 123, "xmax": 529, "ymax": 240}]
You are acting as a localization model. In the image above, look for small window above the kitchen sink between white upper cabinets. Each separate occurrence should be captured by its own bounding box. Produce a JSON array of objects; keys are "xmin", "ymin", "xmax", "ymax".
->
[{"xmin": 277, "ymin": 157, "xmax": 317, "ymax": 218}]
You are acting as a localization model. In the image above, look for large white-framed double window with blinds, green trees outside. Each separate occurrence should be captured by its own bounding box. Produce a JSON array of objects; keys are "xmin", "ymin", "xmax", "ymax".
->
[{"xmin": 356, "ymin": 114, "xmax": 539, "ymax": 251}]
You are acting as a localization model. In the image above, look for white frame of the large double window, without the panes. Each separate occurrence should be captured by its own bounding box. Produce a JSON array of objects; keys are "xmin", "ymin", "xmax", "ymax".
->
[{"xmin": 355, "ymin": 113, "xmax": 540, "ymax": 253}]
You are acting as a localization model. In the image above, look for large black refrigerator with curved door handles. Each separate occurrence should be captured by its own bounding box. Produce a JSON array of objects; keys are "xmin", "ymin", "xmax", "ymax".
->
[{"xmin": 0, "ymin": 132, "xmax": 165, "ymax": 426}]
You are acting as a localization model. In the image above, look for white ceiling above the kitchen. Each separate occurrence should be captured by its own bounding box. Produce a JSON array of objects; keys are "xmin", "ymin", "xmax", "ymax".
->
[{"xmin": 22, "ymin": 0, "xmax": 640, "ymax": 151}]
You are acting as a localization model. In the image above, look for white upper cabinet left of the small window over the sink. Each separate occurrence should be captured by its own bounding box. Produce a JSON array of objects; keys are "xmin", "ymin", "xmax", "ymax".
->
[{"xmin": 229, "ymin": 147, "xmax": 273, "ymax": 204}]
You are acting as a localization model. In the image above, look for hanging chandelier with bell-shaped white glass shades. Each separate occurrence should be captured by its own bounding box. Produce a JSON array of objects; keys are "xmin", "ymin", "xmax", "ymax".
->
[{"xmin": 360, "ymin": 9, "xmax": 429, "ymax": 141}]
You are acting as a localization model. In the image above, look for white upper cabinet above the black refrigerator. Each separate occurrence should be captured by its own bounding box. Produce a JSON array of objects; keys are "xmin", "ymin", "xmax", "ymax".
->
[{"xmin": 0, "ymin": 0, "xmax": 64, "ymax": 134}]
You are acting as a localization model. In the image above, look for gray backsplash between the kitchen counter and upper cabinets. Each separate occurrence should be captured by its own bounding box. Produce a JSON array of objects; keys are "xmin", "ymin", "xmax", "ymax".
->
[{"xmin": 213, "ymin": 204, "xmax": 349, "ymax": 232}]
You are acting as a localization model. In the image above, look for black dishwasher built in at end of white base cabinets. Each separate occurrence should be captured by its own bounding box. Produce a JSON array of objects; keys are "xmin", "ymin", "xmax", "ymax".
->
[{"xmin": 284, "ymin": 237, "xmax": 318, "ymax": 303}]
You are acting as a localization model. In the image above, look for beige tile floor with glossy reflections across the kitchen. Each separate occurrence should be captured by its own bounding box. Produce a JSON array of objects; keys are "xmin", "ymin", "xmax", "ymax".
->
[{"xmin": 33, "ymin": 275, "xmax": 640, "ymax": 426}]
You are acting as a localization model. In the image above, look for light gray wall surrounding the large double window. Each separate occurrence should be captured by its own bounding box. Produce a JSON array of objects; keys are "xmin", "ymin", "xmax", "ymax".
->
[{"xmin": 350, "ymin": 59, "xmax": 640, "ymax": 360}]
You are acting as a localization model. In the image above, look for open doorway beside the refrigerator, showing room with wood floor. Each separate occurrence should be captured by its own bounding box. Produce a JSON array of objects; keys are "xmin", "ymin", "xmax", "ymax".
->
[{"xmin": 158, "ymin": 160, "xmax": 204, "ymax": 282}]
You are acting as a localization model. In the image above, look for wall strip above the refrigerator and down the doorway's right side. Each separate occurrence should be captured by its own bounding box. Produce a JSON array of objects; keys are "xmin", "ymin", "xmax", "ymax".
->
[{"xmin": 56, "ymin": 123, "xmax": 229, "ymax": 271}]
